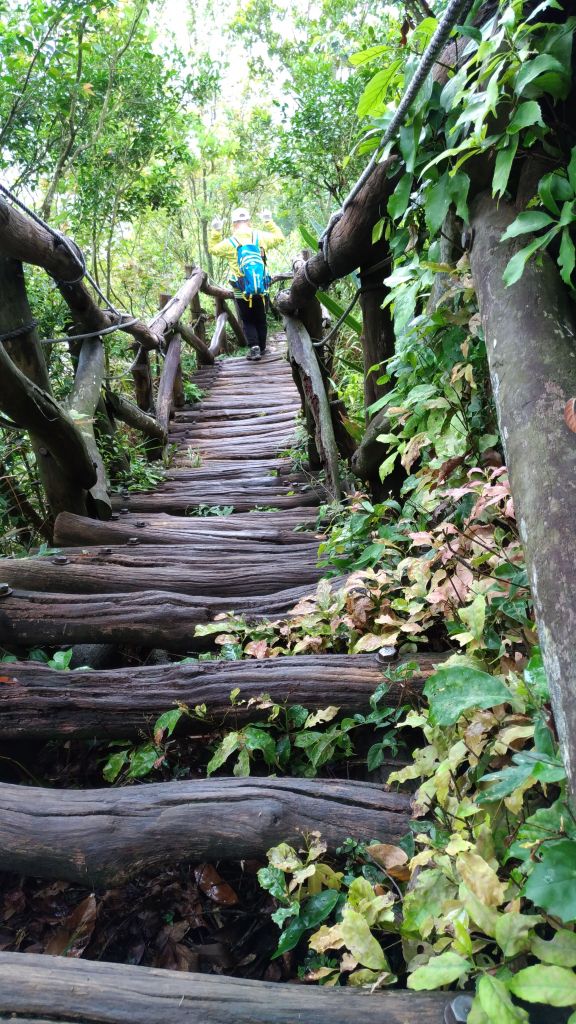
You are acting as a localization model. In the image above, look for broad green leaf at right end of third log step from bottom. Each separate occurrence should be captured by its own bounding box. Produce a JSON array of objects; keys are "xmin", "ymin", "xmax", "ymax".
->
[{"xmin": 424, "ymin": 665, "xmax": 511, "ymax": 725}]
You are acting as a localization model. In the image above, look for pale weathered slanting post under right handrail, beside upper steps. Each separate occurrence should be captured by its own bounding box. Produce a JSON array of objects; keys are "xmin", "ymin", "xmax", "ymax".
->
[{"xmin": 285, "ymin": 316, "xmax": 341, "ymax": 500}]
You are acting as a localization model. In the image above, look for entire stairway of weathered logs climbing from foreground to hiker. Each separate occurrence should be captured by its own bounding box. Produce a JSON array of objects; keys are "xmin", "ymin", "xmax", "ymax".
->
[{"xmin": 0, "ymin": 351, "xmax": 451, "ymax": 1024}]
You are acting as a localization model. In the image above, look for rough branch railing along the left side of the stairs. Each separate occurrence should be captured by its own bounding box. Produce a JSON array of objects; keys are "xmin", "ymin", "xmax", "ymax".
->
[{"xmin": 0, "ymin": 199, "xmax": 246, "ymax": 519}]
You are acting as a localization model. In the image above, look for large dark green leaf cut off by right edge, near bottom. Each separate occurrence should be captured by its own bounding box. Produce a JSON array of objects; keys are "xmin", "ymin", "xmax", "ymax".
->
[{"xmin": 524, "ymin": 839, "xmax": 576, "ymax": 922}]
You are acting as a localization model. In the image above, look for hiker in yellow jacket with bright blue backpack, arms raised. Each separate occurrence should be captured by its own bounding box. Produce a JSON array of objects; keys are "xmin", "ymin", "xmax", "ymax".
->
[{"xmin": 208, "ymin": 207, "xmax": 284, "ymax": 359}]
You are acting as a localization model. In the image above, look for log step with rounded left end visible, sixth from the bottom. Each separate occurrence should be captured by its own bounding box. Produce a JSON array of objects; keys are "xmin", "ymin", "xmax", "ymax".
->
[{"xmin": 54, "ymin": 509, "xmax": 321, "ymax": 548}]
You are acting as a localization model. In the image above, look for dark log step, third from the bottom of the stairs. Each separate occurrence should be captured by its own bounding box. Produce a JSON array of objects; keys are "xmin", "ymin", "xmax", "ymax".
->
[{"xmin": 0, "ymin": 654, "xmax": 438, "ymax": 739}]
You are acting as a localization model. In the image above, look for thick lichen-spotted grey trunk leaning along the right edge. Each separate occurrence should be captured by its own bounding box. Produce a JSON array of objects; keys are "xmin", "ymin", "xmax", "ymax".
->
[{"xmin": 470, "ymin": 194, "xmax": 576, "ymax": 799}]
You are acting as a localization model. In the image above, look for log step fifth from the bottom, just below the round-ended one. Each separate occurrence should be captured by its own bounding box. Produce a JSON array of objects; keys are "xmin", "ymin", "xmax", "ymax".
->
[{"xmin": 0, "ymin": 552, "xmax": 323, "ymax": 604}]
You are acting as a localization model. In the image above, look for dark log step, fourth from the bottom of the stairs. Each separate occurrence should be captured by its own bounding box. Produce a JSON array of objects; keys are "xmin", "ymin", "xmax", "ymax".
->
[{"xmin": 0, "ymin": 584, "xmax": 336, "ymax": 651}]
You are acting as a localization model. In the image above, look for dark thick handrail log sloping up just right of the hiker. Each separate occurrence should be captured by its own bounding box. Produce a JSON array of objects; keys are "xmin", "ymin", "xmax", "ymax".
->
[{"xmin": 276, "ymin": 157, "xmax": 397, "ymax": 316}]
